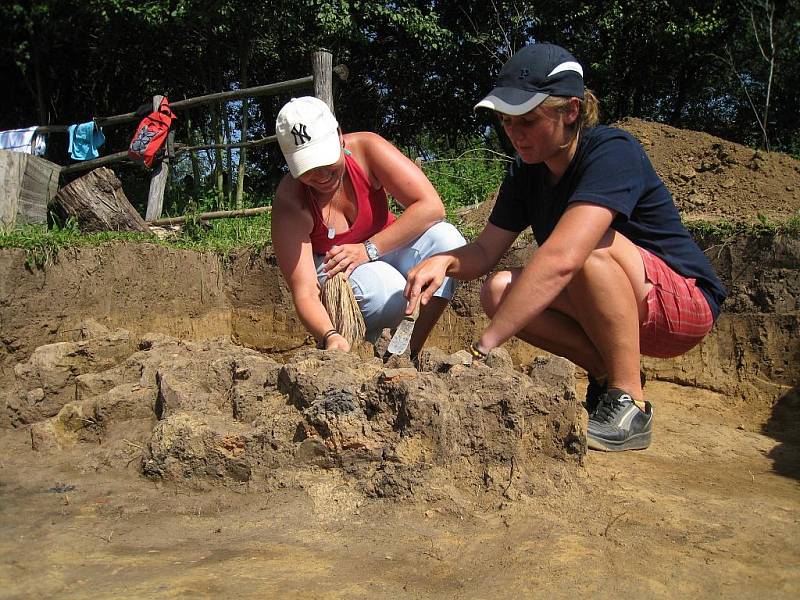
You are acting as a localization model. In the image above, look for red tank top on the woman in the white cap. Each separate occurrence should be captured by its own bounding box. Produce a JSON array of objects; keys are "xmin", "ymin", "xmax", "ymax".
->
[{"xmin": 305, "ymin": 150, "xmax": 397, "ymax": 254}]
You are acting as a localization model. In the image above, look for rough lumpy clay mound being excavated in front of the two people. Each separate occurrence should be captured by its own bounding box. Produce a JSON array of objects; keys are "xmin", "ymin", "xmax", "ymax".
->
[{"xmin": 0, "ymin": 328, "xmax": 586, "ymax": 498}]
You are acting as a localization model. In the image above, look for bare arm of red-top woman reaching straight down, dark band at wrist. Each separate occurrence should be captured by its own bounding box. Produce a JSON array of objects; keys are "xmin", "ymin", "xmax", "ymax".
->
[{"xmin": 272, "ymin": 176, "xmax": 350, "ymax": 350}]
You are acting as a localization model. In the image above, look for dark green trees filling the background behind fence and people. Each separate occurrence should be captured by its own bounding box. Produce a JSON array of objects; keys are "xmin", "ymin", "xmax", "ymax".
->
[{"xmin": 0, "ymin": 0, "xmax": 800, "ymax": 206}]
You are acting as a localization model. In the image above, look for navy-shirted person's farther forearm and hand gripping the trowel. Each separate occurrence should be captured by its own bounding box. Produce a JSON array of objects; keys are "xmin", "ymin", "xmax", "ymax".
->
[{"xmin": 405, "ymin": 223, "xmax": 519, "ymax": 314}]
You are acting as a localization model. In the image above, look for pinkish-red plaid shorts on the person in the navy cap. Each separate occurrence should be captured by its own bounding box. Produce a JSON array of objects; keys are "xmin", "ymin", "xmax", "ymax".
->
[{"xmin": 639, "ymin": 248, "xmax": 714, "ymax": 358}]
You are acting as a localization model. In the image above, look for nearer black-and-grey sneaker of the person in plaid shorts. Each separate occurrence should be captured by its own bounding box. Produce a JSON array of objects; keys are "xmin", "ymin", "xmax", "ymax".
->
[{"xmin": 586, "ymin": 388, "xmax": 653, "ymax": 452}]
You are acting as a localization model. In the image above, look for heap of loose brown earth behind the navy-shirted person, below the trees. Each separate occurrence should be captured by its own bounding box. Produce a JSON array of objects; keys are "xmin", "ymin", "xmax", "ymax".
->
[{"xmin": 461, "ymin": 119, "xmax": 800, "ymax": 229}]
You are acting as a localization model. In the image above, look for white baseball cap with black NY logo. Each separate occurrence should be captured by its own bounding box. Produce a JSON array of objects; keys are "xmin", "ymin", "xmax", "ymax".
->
[{"xmin": 275, "ymin": 96, "xmax": 342, "ymax": 179}]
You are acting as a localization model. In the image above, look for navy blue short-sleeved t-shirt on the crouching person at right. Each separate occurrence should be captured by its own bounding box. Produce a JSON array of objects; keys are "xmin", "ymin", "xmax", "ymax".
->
[{"xmin": 489, "ymin": 125, "xmax": 727, "ymax": 319}]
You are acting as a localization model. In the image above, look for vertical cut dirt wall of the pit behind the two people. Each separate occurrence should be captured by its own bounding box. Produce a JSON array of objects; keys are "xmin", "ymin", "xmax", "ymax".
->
[{"xmin": 0, "ymin": 236, "xmax": 800, "ymax": 410}]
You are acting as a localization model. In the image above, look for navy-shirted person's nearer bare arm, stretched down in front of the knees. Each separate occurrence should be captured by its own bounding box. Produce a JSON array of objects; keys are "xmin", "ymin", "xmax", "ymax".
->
[{"xmin": 478, "ymin": 203, "xmax": 615, "ymax": 352}]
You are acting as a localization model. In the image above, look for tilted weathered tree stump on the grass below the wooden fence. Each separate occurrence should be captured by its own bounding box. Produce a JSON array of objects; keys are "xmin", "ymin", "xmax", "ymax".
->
[{"xmin": 56, "ymin": 167, "xmax": 150, "ymax": 233}]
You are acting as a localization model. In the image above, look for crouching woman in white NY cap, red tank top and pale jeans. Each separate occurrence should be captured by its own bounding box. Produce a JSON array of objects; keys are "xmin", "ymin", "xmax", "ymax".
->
[{"xmin": 272, "ymin": 97, "xmax": 465, "ymax": 355}]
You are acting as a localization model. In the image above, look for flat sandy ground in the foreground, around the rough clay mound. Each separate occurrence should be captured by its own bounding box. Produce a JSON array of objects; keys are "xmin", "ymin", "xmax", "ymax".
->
[{"xmin": 0, "ymin": 382, "xmax": 800, "ymax": 599}]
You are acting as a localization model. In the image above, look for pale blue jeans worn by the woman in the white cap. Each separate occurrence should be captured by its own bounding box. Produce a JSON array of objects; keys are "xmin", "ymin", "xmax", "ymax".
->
[{"xmin": 314, "ymin": 223, "xmax": 467, "ymax": 342}]
